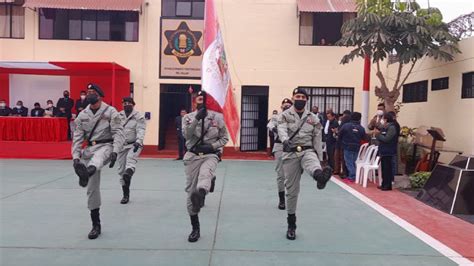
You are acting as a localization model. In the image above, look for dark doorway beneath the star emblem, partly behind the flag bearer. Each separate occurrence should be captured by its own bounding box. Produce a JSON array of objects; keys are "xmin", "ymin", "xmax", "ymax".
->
[{"xmin": 158, "ymin": 84, "xmax": 201, "ymax": 151}]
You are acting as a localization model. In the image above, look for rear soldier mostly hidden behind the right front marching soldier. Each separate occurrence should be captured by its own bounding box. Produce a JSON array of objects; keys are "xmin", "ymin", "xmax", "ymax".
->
[{"xmin": 267, "ymin": 98, "xmax": 293, "ymax": 210}]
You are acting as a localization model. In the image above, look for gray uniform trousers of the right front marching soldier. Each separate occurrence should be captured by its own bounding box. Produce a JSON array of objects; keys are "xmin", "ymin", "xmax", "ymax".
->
[{"xmin": 282, "ymin": 149, "xmax": 321, "ymax": 214}]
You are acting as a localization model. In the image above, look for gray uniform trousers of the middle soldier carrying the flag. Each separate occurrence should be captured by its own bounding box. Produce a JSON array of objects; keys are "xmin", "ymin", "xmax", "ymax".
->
[{"xmin": 183, "ymin": 151, "xmax": 219, "ymax": 215}]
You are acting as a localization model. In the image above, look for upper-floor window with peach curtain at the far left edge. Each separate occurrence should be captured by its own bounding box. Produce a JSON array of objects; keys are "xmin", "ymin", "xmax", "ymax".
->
[{"xmin": 0, "ymin": 0, "xmax": 25, "ymax": 39}]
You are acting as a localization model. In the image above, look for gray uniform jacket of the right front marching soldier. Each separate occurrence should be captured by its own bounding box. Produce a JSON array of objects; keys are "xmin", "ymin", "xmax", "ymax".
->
[{"xmin": 278, "ymin": 106, "xmax": 323, "ymax": 161}]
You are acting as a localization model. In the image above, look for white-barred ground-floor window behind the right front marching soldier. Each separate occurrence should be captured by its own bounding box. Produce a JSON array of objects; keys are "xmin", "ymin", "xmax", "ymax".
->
[{"xmin": 300, "ymin": 87, "xmax": 354, "ymax": 114}]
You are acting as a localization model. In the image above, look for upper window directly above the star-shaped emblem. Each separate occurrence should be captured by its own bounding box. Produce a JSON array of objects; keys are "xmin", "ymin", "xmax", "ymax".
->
[{"xmin": 161, "ymin": 0, "xmax": 204, "ymax": 18}]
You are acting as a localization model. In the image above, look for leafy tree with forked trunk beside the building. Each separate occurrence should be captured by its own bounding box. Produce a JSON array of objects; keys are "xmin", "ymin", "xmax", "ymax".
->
[{"xmin": 337, "ymin": 0, "xmax": 460, "ymax": 111}]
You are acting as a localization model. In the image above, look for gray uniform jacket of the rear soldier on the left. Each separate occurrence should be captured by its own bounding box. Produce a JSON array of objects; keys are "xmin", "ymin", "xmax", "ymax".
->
[{"xmin": 119, "ymin": 110, "xmax": 146, "ymax": 146}]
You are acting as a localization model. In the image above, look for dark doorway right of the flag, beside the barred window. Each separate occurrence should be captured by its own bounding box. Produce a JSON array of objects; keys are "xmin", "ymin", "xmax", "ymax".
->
[{"xmin": 240, "ymin": 86, "xmax": 268, "ymax": 151}]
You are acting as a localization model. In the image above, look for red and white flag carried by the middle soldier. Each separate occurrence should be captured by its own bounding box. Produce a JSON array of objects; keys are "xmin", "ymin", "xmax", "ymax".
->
[{"xmin": 202, "ymin": 0, "xmax": 240, "ymax": 145}]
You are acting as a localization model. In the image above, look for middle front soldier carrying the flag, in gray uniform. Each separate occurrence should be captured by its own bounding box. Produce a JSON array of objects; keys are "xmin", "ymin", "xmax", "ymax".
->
[{"xmin": 182, "ymin": 91, "xmax": 229, "ymax": 242}]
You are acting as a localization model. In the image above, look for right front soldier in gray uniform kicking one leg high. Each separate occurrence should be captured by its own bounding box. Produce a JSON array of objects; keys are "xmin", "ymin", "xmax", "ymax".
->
[{"xmin": 278, "ymin": 88, "xmax": 332, "ymax": 240}]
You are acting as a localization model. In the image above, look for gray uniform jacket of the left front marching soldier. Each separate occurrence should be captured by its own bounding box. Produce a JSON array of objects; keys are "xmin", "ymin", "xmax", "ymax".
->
[{"xmin": 72, "ymin": 102, "xmax": 125, "ymax": 159}]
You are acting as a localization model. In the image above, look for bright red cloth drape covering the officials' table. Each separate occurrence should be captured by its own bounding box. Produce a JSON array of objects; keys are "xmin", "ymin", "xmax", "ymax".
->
[{"xmin": 0, "ymin": 117, "xmax": 68, "ymax": 142}]
